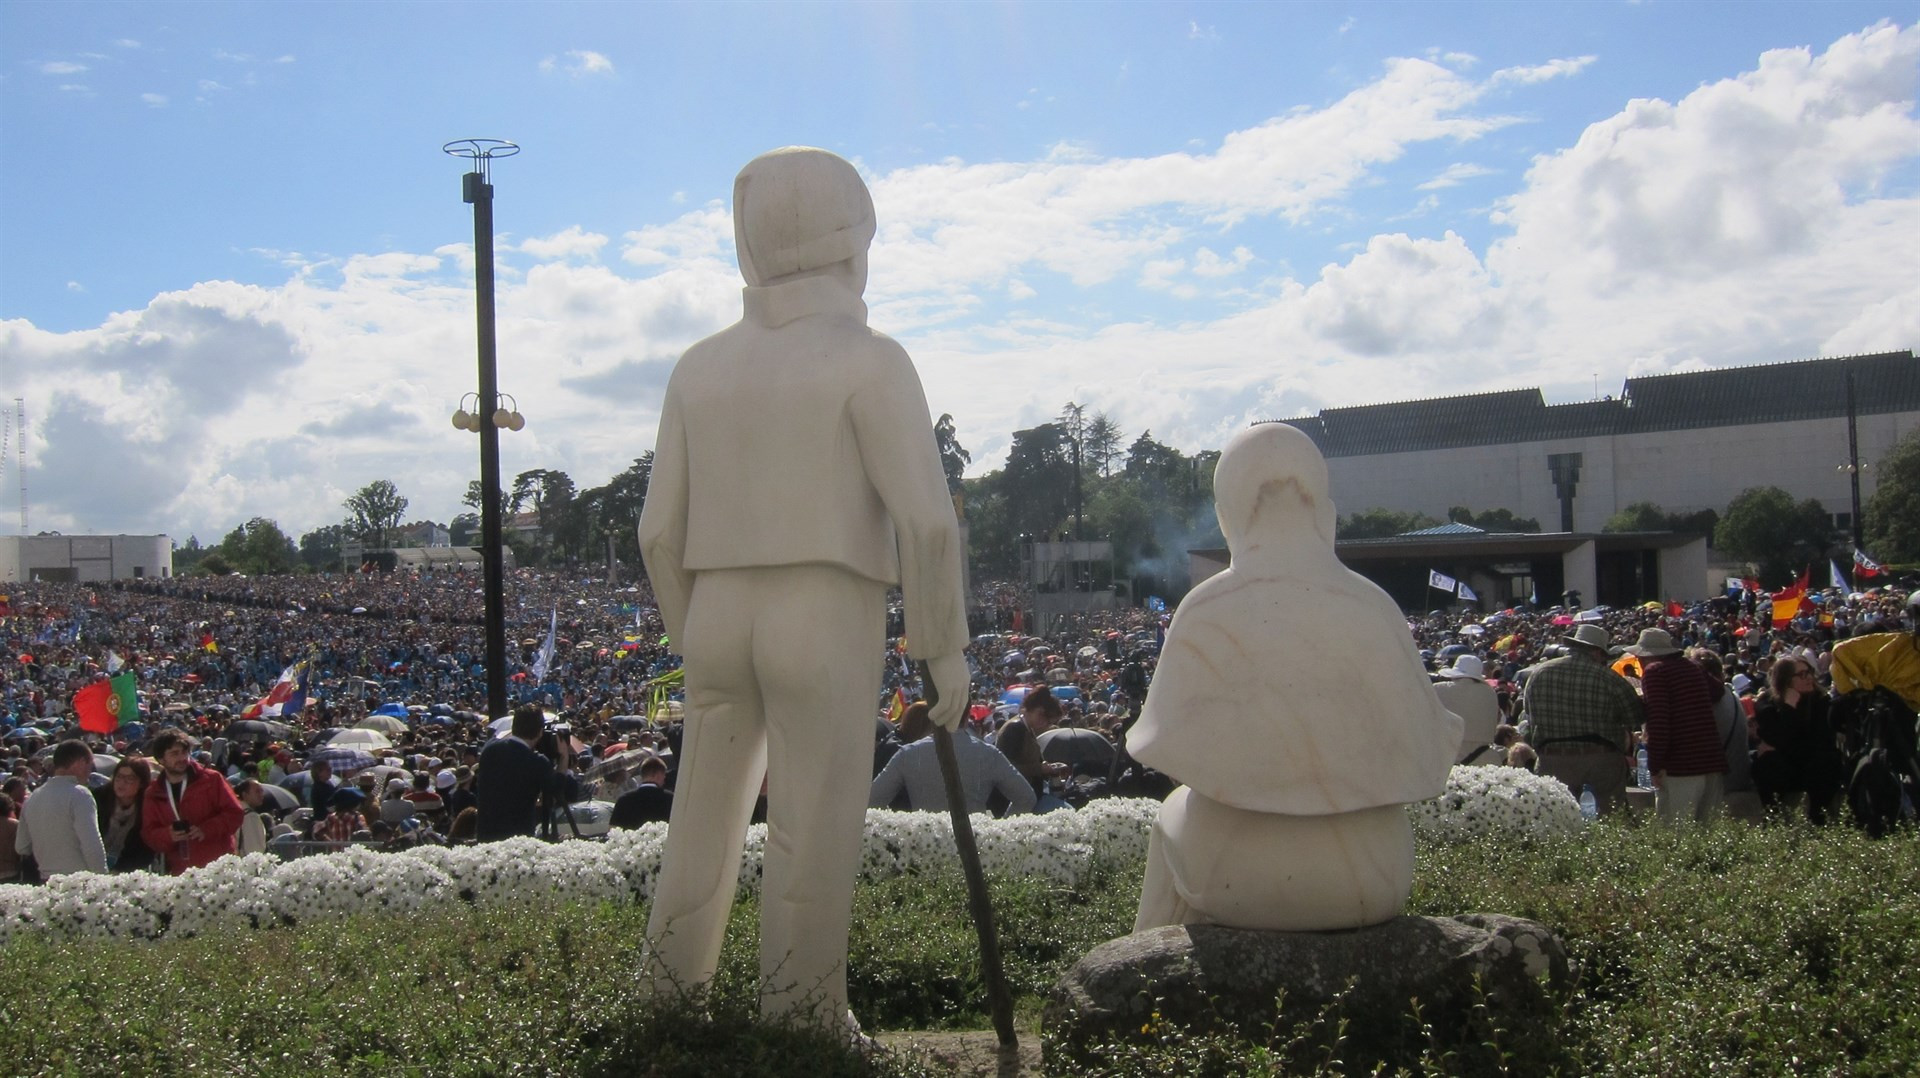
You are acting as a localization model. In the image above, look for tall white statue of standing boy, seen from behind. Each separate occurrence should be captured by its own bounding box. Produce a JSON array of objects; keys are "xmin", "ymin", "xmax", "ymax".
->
[{"xmin": 639, "ymin": 146, "xmax": 968, "ymax": 1026}]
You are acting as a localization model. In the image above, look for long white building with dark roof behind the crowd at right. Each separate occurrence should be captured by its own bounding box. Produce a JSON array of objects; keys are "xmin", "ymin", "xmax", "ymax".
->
[{"xmin": 1286, "ymin": 352, "xmax": 1920, "ymax": 532}]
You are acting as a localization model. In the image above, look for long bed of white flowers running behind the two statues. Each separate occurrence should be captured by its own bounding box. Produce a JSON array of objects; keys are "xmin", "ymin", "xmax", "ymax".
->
[{"xmin": 0, "ymin": 767, "xmax": 1559, "ymax": 943}]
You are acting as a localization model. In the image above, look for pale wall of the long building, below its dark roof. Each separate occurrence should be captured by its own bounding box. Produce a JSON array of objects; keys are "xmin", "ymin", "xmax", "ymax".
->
[{"xmin": 1327, "ymin": 411, "xmax": 1920, "ymax": 532}]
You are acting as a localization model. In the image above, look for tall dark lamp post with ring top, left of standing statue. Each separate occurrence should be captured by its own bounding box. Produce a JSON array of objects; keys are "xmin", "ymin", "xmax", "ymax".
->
[{"xmin": 442, "ymin": 138, "xmax": 524, "ymax": 719}]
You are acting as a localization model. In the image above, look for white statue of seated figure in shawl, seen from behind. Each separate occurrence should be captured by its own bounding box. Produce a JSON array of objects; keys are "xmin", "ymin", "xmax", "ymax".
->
[{"xmin": 1127, "ymin": 423, "xmax": 1461, "ymax": 932}]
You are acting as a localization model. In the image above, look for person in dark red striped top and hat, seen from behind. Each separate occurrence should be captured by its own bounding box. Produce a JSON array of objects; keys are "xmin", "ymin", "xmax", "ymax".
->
[{"xmin": 1626, "ymin": 628, "xmax": 1726, "ymax": 822}]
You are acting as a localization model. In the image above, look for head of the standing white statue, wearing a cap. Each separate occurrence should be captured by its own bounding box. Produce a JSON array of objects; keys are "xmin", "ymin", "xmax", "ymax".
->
[{"xmin": 733, "ymin": 146, "xmax": 874, "ymax": 292}]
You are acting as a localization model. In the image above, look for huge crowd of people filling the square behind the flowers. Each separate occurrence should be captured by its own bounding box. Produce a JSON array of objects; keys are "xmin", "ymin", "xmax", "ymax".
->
[{"xmin": 0, "ymin": 571, "xmax": 1920, "ymax": 880}]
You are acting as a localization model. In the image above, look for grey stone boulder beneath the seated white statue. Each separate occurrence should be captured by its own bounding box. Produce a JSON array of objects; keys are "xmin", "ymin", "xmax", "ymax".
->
[{"xmin": 1044, "ymin": 913, "xmax": 1571, "ymax": 1065}]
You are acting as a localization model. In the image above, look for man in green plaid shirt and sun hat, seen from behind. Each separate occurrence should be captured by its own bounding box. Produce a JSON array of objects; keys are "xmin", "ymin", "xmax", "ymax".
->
[{"xmin": 1526, "ymin": 625, "xmax": 1642, "ymax": 815}]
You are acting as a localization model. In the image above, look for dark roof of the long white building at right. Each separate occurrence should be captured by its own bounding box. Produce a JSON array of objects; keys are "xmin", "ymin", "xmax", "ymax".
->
[{"xmin": 1284, "ymin": 350, "xmax": 1920, "ymax": 457}]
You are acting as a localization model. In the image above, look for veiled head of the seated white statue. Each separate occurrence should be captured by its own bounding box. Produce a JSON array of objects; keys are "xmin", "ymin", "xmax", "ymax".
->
[{"xmin": 1213, "ymin": 423, "xmax": 1334, "ymax": 561}]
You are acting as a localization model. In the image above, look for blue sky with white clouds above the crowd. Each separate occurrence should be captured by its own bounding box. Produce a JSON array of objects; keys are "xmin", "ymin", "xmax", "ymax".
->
[{"xmin": 0, "ymin": 2, "xmax": 1920, "ymax": 540}]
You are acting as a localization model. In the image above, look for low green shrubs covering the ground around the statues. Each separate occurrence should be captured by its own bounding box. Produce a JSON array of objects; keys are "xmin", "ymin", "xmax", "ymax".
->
[{"xmin": 0, "ymin": 821, "xmax": 1920, "ymax": 1078}]
